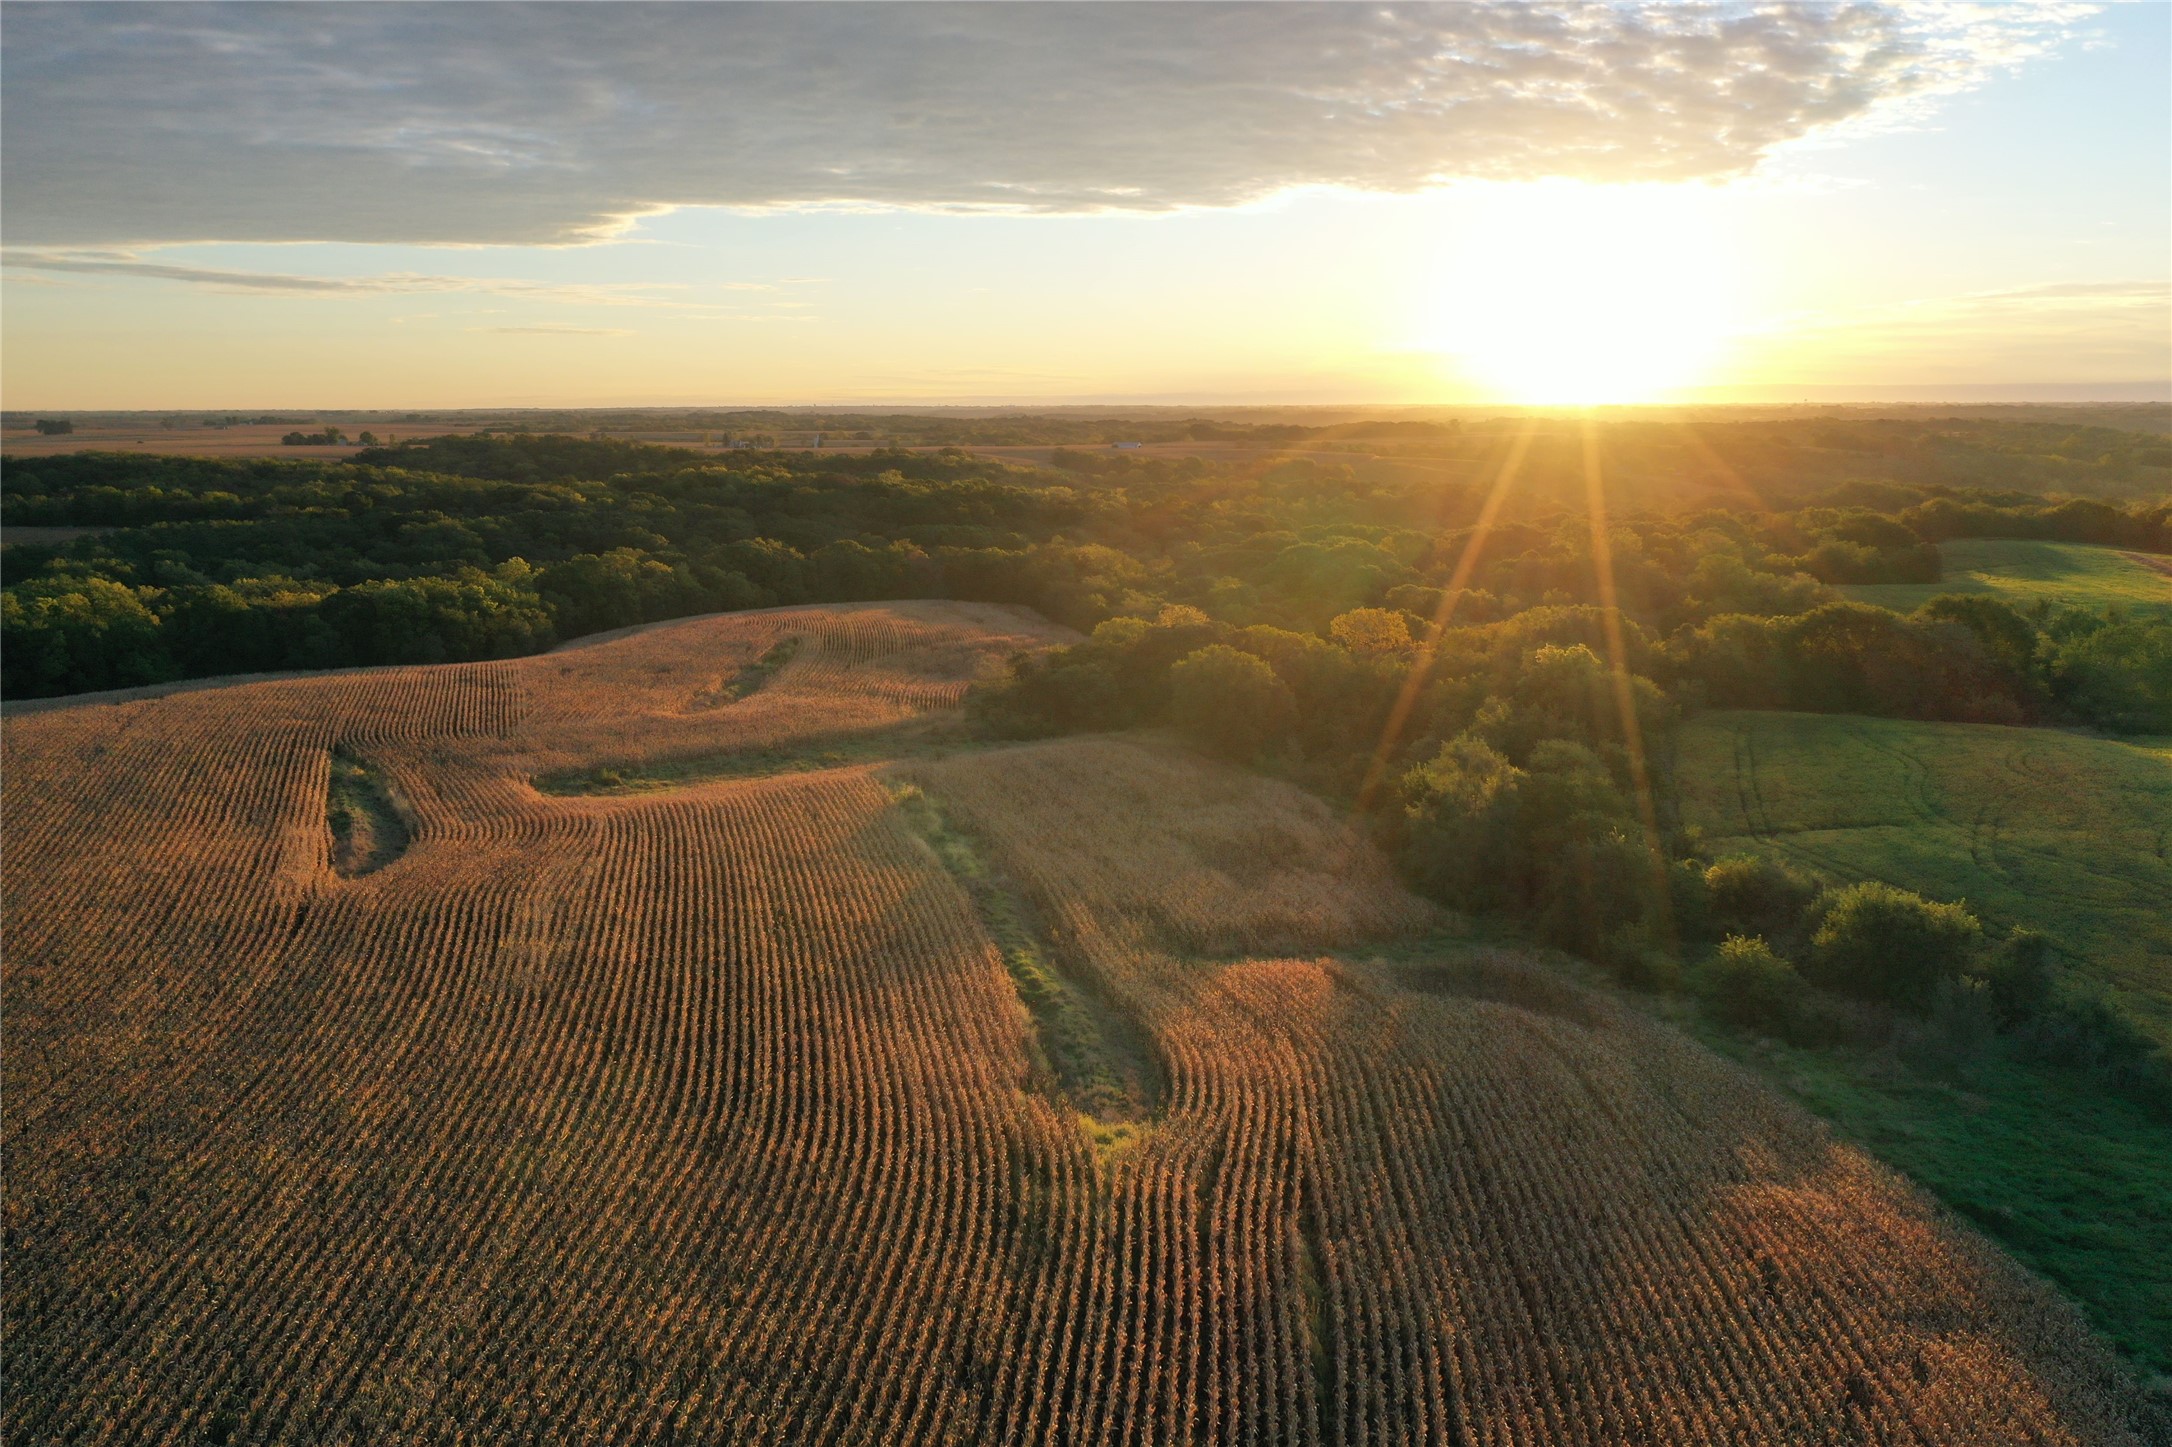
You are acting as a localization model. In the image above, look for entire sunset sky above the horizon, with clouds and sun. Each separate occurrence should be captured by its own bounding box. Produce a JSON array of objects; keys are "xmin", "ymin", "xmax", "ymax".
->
[{"xmin": 0, "ymin": 0, "xmax": 2172, "ymax": 411}]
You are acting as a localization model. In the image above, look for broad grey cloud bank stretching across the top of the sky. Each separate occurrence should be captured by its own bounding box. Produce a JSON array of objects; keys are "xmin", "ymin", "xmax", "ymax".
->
[{"xmin": 0, "ymin": 0, "xmax": 2087, "ymax": 246}]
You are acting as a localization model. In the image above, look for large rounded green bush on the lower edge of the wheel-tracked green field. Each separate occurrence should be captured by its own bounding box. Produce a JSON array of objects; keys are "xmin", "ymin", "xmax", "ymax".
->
[{"xmin": 1809, "ymin": 882, "xmax": 1983, "ymax": 1010}]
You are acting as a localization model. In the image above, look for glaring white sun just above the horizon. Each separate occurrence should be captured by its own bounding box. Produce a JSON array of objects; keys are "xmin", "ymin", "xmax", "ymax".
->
[{"xmin": 1418, "ymin": 183, "xmax": 1738, "ymax": 406}]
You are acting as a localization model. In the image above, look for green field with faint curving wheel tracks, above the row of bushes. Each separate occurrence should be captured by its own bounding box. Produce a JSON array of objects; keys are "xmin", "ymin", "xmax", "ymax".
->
[{"xmin": 1679, "ymin": 713, "xmax": 2172, "ymax": 1041}]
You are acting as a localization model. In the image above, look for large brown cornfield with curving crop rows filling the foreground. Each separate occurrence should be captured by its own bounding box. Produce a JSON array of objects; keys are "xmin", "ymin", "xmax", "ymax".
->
[{"xmin": 0, "ymin": 602, "xmax": 2137, "ymax": 1445}]
